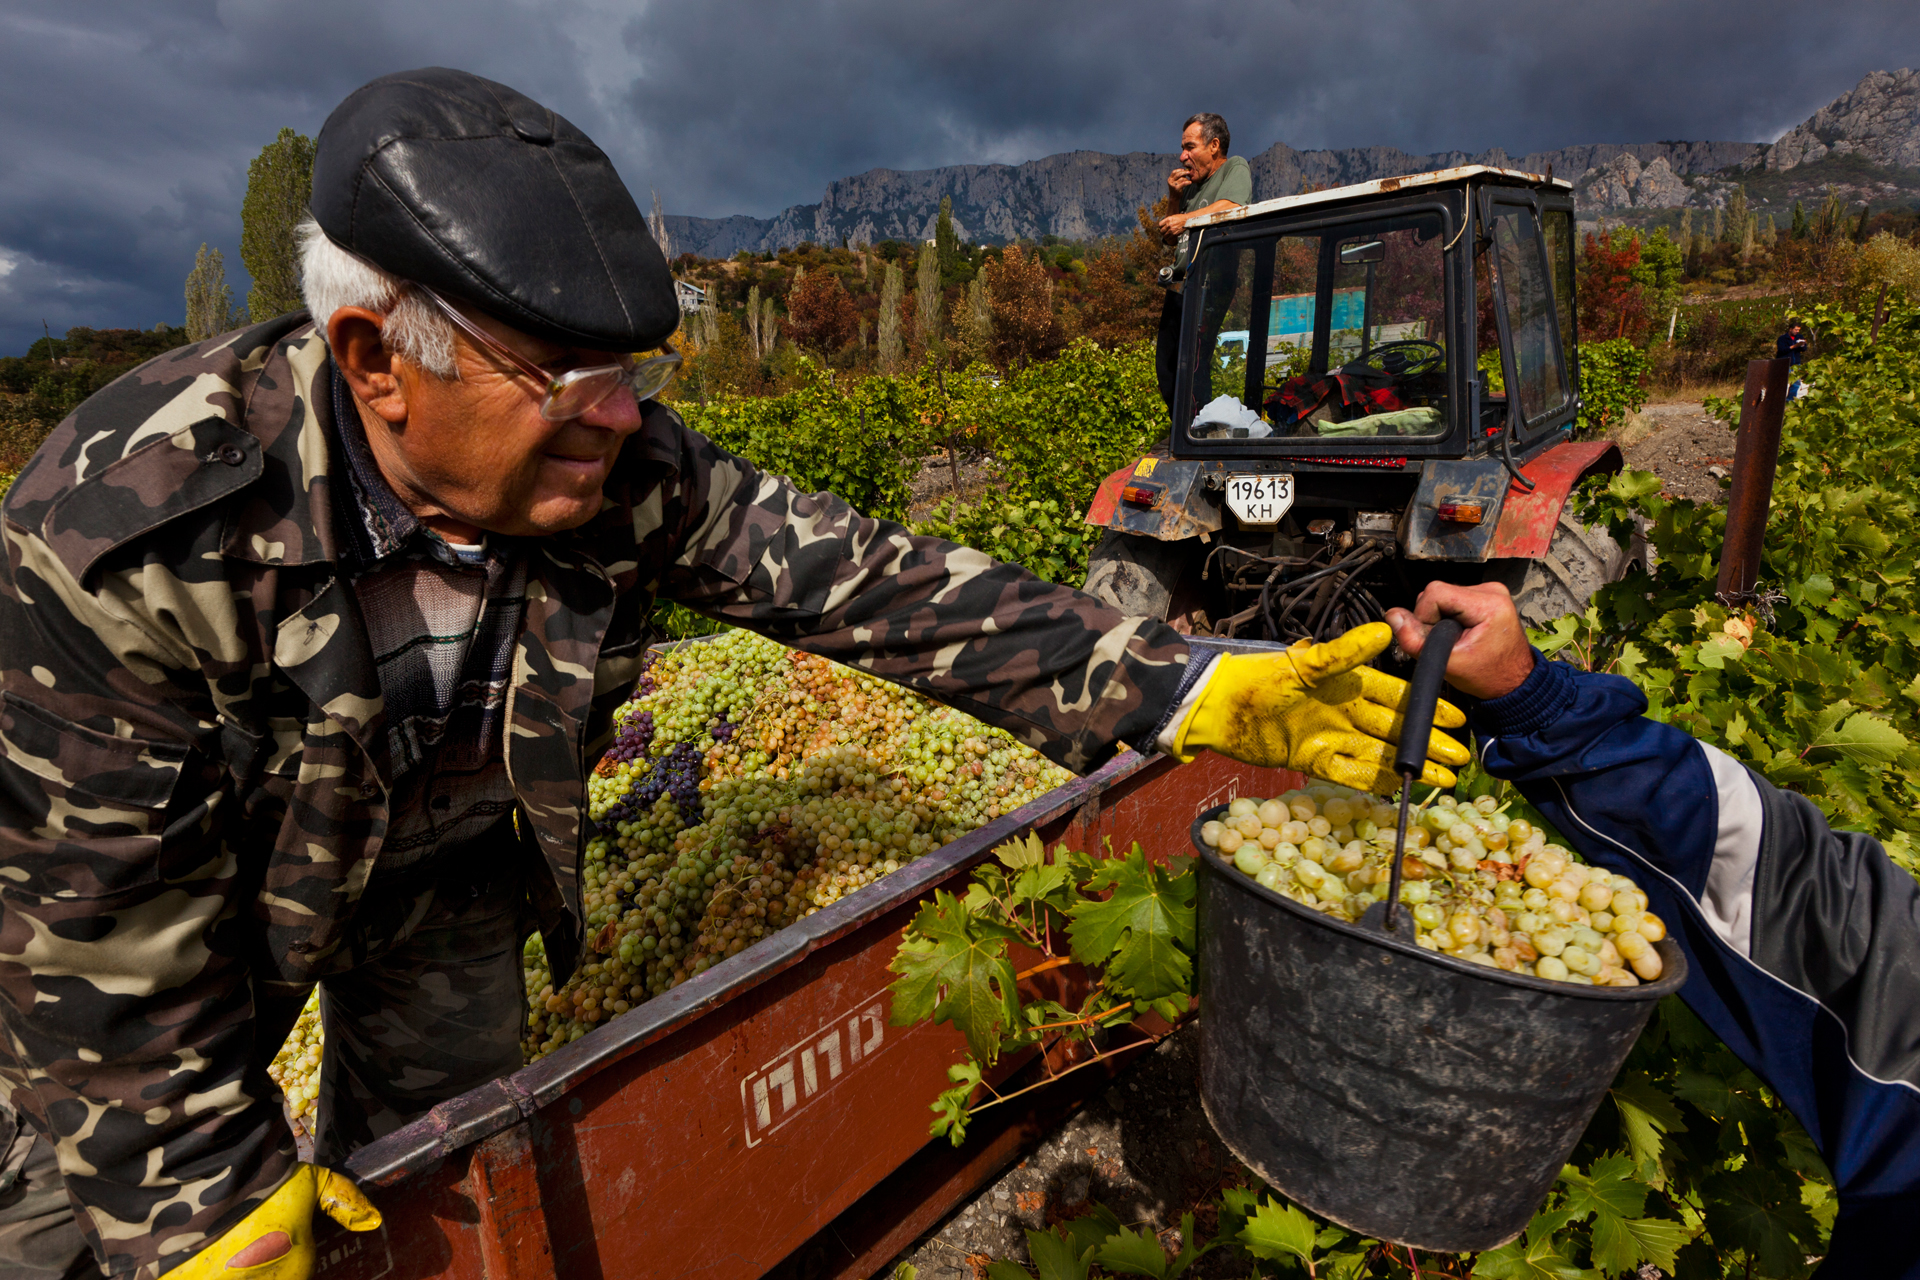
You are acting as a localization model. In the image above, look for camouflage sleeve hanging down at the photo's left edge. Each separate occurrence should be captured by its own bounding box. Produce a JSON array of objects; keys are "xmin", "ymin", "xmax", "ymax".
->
[{"xmin": 0, "ymin": 477, "xmax": 296, "ymax": 1276}]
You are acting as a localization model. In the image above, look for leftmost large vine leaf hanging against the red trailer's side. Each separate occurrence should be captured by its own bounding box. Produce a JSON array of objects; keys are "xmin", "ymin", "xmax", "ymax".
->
[{"xmin": 887, "ymin": 890, "xmax": 1020, "ymax": 1063}]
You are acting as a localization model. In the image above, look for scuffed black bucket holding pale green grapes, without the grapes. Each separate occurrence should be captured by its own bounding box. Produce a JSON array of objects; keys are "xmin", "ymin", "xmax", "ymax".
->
[{"xmin": 1192, "ymin": 806, "xmax": 1686, "ymax": 1253}]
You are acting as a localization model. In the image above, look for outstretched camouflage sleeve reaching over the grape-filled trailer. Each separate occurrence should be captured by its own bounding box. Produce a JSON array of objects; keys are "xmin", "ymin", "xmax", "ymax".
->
[{"xmin": 660, "ymin": 428, "xmax": 1188, "ymax": 773}]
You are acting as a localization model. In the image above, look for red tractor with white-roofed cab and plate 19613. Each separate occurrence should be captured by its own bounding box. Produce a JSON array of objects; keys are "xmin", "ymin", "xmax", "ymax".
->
[{"xmin": 1087, "ymin": 165, "xmax": 1630, "ymax": 641}]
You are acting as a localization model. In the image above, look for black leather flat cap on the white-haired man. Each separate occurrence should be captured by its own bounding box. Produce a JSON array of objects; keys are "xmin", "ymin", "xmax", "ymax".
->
[{"xmin": 313, "ymin": 67, "xmax": 680, "ymax": 351}]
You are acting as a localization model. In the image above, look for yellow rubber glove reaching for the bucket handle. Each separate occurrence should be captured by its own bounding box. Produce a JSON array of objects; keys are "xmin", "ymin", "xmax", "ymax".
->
[{"xmin": 1173, "ymin": 622, "xmax": 1471, "ymax": 796}]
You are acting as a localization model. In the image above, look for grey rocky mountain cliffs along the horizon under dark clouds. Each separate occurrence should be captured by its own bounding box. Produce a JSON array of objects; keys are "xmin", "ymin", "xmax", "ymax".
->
[{"xmin": 666, "ymin": 71, "xmax": 1920, "ymax": 257}]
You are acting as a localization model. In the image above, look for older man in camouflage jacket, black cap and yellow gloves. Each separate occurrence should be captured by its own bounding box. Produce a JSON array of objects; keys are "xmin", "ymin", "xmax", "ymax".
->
[{"xmin": 0, "ymin": 67, "xmax": 1467, "ymax": 1280}]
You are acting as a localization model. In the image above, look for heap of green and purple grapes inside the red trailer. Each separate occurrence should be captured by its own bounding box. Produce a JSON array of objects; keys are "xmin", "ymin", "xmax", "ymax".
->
[{"xmin": 524, "ymin": 631, "xmax": 1068, "ymax": 1059}]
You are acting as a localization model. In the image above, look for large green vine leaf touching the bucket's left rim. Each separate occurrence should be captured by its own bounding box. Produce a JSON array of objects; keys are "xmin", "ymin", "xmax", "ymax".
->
[{"xmin": 1068, "ymin": 844, "xmax": 1194, "ymax": 1000}]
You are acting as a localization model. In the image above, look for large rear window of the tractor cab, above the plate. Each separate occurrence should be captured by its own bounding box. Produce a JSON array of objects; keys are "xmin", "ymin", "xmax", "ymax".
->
[{"xmin": 1183, "ymin": 213, "xmax": 1448, "ymax": 439}]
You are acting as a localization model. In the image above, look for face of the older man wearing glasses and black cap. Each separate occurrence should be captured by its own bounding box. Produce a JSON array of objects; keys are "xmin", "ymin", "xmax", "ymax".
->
[{"xmin": 369, "ymin": 311, "xmax": 639, "ymax": 537}]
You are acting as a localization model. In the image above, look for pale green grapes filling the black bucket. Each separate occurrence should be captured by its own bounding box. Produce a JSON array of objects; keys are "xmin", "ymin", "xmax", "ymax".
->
[{"xmin": 1200, "ymin": 783, "xmax": 1667, "ymax": 986}]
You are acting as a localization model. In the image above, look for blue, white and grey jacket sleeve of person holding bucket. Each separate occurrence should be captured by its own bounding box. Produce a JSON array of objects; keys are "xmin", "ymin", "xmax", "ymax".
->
[{"xmin": 1471, "ymin": 656, "xmax": 1920, "ymax": 1278}]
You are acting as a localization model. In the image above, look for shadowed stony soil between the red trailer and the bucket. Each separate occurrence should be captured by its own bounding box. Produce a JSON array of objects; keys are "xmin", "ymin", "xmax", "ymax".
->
[{"xmin": 879, "ymin": 1023, "xmax": 1250, "ymax": 1280}]
